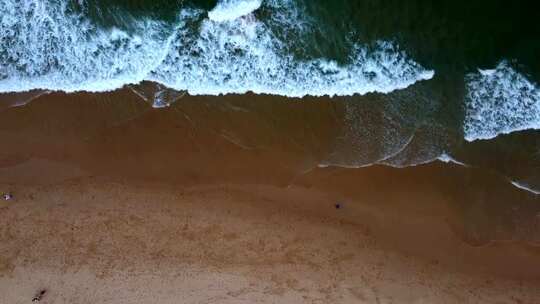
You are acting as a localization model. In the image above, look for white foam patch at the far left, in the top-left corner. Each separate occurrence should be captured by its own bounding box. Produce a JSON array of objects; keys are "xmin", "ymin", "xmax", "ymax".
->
[{"xmin": 0, "ymin": 0, "xmax": 171, "ymax": 92}]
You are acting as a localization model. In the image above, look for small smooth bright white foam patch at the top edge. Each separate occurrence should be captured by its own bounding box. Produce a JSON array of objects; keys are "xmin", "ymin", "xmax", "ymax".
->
[{"xmin": 208, "ymin": 0, "xmax": 262, "ymax": 22}]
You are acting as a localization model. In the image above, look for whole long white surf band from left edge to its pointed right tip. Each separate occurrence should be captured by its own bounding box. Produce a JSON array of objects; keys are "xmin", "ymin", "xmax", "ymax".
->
[{"xmin": 0, "ymin": 0, "xmax": 433, "ymax": 97}]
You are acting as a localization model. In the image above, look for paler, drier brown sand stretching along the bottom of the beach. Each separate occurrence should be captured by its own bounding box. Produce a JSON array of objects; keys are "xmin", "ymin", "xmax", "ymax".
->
[{"xmin": 0, "ymin": 179, "xmax": 540, "ymax": 303}]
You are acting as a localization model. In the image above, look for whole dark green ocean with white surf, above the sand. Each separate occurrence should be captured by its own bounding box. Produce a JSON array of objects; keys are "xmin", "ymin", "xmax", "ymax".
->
[{"xmin": 0, "ymin": 0, "xmax": 540, "ymax": 195}]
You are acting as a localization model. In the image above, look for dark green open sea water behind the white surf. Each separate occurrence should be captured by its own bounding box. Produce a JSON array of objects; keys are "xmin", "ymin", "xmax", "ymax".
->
[{"xmin": 73, "ymin": 0, "xmax": 540, "ymax": 73}]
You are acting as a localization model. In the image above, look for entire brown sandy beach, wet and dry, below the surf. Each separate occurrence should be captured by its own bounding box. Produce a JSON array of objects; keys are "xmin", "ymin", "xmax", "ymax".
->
[{"xmin": 0, "ymin": 91, "xmax": 540, "ymax": 303}]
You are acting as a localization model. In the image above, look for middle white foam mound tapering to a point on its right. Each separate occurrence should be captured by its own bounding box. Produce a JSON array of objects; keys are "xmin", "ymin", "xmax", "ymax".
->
[{"xmin": 149, "ymin": 7, "xmax": 434, "ymax": 97}]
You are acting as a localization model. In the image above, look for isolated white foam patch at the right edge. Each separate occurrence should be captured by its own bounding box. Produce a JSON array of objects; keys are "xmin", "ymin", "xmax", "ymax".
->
[{"xmin": 464, "ymin": 62, "xmax": 540, "ymax": 141}]
